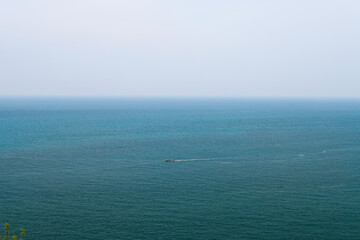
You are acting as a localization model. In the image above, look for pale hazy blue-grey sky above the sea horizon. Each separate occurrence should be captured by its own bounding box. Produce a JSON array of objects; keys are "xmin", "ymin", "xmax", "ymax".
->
[{"xmin": 0, "ymin": 0, "xmax": 360, "ymax": 97}]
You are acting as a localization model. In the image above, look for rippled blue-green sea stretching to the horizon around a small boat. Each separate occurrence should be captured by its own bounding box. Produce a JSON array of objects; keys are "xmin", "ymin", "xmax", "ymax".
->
[{"xmin": 0, "ymin": 98, "xmax": 360, "ymax": 240}]
